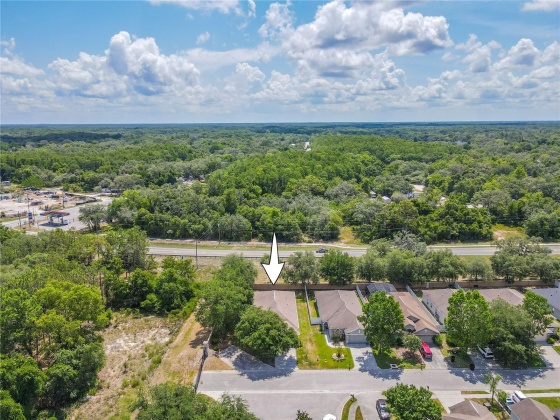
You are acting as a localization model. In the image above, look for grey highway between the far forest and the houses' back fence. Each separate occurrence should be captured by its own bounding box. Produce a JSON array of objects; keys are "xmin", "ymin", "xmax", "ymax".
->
[{"xmin": 148, "ymin": 245, "xmax": 560, "ymax": 258}]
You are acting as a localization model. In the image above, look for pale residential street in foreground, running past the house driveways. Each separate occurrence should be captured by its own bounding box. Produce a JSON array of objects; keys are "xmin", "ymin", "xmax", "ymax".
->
[{"xmin": 198, "ymin": 369, "xmax": 560, "ymax": 420}]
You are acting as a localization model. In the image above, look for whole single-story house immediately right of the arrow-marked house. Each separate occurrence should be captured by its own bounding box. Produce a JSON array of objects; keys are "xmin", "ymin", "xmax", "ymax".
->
[{"xmin": 315, "ymin": 290, "xmax": 367, "ymax": 344}]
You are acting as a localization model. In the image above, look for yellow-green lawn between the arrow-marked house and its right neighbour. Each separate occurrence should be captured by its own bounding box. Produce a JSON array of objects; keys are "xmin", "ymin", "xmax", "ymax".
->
[{"xmin": 296, "ymin": 298, "xmax": 354, "ymax": 369}]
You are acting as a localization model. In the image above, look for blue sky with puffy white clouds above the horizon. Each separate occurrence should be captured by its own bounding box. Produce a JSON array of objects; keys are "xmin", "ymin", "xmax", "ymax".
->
[{"xmin": 0, "ymin": 0, "xmax": 560, "ymax": 124}]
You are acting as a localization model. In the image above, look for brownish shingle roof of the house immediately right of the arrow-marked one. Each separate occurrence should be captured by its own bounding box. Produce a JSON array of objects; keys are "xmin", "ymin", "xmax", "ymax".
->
[{"xmin": 315, "ymin": 290, "xmax": 364, "ymax": 331}]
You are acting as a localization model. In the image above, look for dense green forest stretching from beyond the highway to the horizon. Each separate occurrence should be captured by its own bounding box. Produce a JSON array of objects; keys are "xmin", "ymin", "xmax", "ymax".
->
[{"xmin": 0, "ymin": 123, "xmax": 560, "ymax": 243}]
